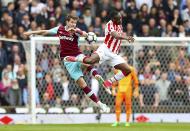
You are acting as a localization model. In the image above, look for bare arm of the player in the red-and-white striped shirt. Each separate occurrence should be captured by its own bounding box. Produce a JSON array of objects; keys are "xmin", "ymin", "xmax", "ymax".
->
[{"xmin": 111, "ymin": 31, "xmax": 135, "ymax": 43}]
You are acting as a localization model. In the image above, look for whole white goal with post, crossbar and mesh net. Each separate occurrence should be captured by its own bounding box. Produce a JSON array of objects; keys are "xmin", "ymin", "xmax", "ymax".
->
[{"xmin": 0, "ymin": 37, "xmax": 190, "ymax": 124}]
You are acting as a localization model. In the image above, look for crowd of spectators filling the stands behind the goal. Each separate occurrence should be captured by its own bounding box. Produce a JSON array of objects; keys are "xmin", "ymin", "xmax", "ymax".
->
[{"xmin": 0, "ymin": 0, "xmax": 190, "ymax": 112}]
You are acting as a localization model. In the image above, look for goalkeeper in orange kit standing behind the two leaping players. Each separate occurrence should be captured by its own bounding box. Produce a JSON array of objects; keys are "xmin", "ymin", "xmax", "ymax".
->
[{"xmin": 112, "ymin": 61, "xmax": 139, "ymax": 126}]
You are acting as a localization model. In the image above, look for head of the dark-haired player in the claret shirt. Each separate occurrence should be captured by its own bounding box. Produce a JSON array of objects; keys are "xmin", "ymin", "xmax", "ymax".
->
[{"xmin": 66, "ymin": 15, "xmax": 79, "ymax": 28}]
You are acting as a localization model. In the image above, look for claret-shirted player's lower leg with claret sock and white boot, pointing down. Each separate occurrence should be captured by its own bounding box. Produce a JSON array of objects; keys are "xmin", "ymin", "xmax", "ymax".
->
[{"xmin": 76, "ymin": 77, "xmax": 109, "ymax": 112}]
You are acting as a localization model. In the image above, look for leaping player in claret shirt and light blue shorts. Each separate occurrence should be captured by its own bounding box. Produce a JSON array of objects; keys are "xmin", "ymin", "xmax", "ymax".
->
[{"xmin": 24, "ymin": 15, "xmax": 111, "ymax": 112}]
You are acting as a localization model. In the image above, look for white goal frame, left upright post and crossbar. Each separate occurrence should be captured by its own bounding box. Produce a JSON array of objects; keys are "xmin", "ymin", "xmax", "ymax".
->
[{"xmin": 27, "ymin": 36, "xmax": 190, "ymax": 123}]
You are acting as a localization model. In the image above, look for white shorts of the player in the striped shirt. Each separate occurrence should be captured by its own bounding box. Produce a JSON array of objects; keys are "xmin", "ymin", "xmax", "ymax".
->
[{"xmin": 95, "ymin": 44, "xmax": 126, "ymax": 67}]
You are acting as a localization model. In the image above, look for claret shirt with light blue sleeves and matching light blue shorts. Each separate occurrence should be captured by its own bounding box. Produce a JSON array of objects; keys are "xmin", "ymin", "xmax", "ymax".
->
[{"xmin": 48, "ymin": 25, "xmax": 83, "ymax": 81}]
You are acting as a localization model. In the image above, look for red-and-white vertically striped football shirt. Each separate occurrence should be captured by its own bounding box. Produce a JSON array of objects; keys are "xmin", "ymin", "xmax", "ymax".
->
[{"xmin": 104, "ymin": 20, "xmax": 123, "ymax": 53}]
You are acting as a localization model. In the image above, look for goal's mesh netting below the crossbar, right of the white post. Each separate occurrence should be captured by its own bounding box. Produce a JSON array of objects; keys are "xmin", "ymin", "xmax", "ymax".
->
[{"xmin": 32, "ymin": 39, "xmax": 190, "ymax": 112}]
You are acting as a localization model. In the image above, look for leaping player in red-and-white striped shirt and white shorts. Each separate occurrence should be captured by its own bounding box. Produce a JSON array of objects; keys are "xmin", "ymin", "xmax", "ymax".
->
[{"xmin": 64, "ymin": 11, "xmax": 134, "ymax": 87}]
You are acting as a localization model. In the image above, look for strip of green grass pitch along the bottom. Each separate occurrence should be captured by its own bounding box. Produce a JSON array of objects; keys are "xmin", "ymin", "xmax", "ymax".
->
[{"xmin": 0, "ymin": 123, "xmax": 190, "ymax": 131}]
